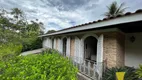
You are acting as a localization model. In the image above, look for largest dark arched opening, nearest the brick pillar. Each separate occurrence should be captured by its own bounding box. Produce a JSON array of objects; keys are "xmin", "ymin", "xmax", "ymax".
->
[{"xmin": 84, "ymin": 36, "xmax": 97, "ymax": 62}]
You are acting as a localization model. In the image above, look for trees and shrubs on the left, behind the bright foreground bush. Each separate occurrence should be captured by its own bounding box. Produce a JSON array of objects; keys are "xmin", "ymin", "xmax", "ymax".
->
[{"xmin": 0, "ymin": 8, "xmax": 43, "ymax": 59}]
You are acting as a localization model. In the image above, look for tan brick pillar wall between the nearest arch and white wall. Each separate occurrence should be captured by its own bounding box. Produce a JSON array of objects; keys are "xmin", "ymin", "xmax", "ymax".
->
[{"xmin": 103, "ymin": 32, "xmax": 125, "ymax": 68}]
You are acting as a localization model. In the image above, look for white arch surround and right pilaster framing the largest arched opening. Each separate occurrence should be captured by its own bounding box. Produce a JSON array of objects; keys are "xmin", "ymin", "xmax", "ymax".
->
[{"xmin": 80, "ymin": 34, "xmax": 103, "ymax": 77}]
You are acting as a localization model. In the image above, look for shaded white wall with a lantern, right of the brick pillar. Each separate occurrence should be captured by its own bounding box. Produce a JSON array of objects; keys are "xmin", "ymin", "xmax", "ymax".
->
[{"xmin": 125, "ymin": 33, "xmax": 142, "ymax": 68}]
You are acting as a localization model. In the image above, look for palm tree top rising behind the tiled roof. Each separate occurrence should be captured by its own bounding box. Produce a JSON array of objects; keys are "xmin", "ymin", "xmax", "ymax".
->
[{"xmin": 104, "ymin": 1, "xmax": 126, "ymax": 17}]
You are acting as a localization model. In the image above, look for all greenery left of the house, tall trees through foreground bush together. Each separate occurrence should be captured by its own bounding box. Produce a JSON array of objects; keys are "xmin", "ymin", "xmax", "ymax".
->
[{"xmin": 0, "ymin": 8, "xmax": 78, "ymax": 80}]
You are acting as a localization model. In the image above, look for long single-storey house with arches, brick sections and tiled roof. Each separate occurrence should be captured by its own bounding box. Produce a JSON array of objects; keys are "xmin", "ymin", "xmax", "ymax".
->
[{"xmin": 41, "ymin": 10, "xmax": 142, "ymax": 79}]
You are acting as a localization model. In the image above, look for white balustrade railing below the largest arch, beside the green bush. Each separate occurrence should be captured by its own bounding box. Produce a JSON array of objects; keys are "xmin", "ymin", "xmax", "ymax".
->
[{"xmin": 71, "ymin": 57, "xmax": 102, "ymax": 80}]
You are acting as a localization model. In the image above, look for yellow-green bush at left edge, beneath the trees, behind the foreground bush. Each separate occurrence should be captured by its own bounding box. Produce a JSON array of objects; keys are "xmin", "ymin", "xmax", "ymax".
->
[{"xmin": 0, "ymin": 43, "xmax": 22, "ymax": 61}]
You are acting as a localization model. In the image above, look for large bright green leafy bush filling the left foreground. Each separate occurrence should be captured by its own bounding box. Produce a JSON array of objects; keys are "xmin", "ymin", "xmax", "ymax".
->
[{"xmin": 0, "ymin": 54, "xmax": 78, "ymax": 80}]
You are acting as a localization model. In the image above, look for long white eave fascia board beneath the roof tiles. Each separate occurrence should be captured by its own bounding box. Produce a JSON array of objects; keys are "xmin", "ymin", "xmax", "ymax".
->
[{"xmin": 39, "ymin": 13, "xmax": 142, "ymax": 37}]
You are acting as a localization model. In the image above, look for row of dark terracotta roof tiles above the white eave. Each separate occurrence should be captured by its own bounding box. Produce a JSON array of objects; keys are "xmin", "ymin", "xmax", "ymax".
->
[{"xmin": 56, "ymin": 9, "xmax": 142, "ymax": 32}]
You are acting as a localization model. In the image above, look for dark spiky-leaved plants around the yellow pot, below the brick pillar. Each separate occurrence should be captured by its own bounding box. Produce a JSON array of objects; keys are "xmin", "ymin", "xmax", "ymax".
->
[{"xmin": 103, "ymin": 67, "xmax": 138, "ymax": 80}]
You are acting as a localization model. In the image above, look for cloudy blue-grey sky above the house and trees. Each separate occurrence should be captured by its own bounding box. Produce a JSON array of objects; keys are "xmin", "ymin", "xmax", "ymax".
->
[{"xmin": 0, "ymin": 0, "xmax": 142, "ymax": 32}]
